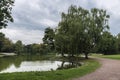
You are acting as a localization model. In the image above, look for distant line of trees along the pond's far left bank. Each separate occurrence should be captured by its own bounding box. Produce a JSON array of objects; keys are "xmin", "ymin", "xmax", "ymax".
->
[{"xmin": 0, "ymin": 33, "xmax": 51, "ymax": 55}]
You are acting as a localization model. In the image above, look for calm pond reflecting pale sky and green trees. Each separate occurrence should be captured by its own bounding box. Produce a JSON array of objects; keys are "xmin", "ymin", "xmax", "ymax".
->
[{"xmin": 0, "ymin": 56, "xmax": 81, "ymax": 73}]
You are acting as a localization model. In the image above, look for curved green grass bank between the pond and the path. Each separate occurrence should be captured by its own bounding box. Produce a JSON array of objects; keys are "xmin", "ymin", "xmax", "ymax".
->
[{"xmin": 0, "ymin": 59, "xmax": 100, "ymax": 80}]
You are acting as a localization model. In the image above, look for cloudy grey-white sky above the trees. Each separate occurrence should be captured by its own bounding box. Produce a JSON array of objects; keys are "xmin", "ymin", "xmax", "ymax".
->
[{"xmin": 1, "ymin": 0, "xmax": 120, "ymax": 44}]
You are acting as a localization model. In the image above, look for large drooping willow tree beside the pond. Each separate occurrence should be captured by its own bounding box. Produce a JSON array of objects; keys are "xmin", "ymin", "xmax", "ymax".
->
[{"xmin": 55, "ymin": 5, "xmax": 109, "ymax": 58}]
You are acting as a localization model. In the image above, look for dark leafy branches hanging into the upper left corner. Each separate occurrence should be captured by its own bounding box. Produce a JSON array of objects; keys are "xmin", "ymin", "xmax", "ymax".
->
[{"xmin": 0, "ymin": 0, "xmax": 14, "ymax": 29}]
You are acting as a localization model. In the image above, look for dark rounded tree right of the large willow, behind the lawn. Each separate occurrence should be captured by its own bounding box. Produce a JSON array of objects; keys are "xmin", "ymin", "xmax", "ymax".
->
[{"xmin": 98, "ymin": 31, "xmax": 117, "ymax": 55}]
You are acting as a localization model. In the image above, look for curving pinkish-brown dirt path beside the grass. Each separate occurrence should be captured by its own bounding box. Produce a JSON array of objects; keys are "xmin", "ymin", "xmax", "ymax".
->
[{"xmin": 74, "ymin": 58, "xmax": 120, "ymax": 80}]
